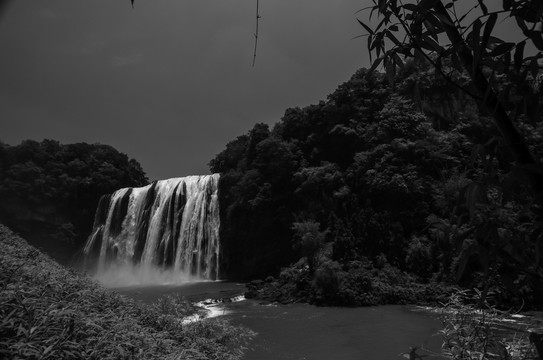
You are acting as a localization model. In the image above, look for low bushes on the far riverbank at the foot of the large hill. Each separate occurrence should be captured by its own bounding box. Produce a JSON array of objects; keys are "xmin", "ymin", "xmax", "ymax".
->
[{"xmin": 245, "ymin": 257, "xmax": 456, "ymax": 306}]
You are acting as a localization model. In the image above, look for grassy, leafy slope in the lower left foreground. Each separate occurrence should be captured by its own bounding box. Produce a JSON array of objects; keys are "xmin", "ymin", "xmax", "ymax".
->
[{"xmin": 0, "ymin": 225, "xmax": 252, "ymax": 359}]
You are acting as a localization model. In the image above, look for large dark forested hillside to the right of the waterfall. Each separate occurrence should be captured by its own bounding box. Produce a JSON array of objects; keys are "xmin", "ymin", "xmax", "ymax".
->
[{"xmin": 210, "ymin": 62, "xmax": 543, "ymax": 304}]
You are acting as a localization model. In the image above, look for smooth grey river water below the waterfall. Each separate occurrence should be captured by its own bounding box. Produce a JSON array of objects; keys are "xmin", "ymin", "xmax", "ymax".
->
[{"xmin": 115, "ymin": 281, "xmax": 441, "ymax": 360}]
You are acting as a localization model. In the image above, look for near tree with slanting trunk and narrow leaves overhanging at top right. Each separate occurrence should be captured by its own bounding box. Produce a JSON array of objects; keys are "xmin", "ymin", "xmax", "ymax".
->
[{"xmin": 359, "ymin": 0, "xmax": 543, "ymax": 198}]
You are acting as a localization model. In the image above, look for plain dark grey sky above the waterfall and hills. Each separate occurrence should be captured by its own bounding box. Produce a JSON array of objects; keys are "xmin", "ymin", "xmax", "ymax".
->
[{"xmin": 0, "ymin": 0, "xmax": 368, "ymax": 179}]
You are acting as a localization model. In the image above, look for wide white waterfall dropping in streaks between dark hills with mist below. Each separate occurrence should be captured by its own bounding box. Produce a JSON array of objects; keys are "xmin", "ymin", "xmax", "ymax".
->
[{"xmin": 83, "ymin": 174, "xmax": 220, "ymax": 286}]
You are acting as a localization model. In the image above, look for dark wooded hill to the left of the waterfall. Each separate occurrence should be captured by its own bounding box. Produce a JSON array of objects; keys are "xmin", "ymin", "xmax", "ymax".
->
[{"xmin": 0, "ymin": 140, "xmax": 147, "ymax": 261}]
